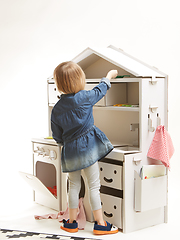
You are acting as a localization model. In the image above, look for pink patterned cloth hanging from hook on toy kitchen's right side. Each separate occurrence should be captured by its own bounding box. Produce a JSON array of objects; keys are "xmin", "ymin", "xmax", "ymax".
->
[{"xmin": 147, "ymin": 125, "xmax": 174, "ymax": 168}]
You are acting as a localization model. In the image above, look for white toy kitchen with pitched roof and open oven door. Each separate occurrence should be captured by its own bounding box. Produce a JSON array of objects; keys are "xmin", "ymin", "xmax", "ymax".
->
[{"xmin": 20, "ymin": 46, "xmax": 168, "ymax": 233}]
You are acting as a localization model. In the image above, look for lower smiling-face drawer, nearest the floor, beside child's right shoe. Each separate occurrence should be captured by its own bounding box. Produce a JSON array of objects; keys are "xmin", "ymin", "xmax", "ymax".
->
[{"xmin": 101, "ymin": 193, "xmax": 123, "ymax": 229}]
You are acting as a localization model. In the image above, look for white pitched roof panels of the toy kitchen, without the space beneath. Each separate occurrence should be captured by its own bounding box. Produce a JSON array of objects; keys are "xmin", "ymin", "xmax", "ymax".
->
[{"xmin": 72, "ymin": 45, "xmax": 167, "ymax": 77}]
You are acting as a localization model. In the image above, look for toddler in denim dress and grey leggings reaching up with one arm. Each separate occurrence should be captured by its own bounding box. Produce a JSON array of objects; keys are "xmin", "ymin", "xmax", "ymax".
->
[{"xmin": 51, "ymin": 61, "xmax": 118, "ymax": 234}]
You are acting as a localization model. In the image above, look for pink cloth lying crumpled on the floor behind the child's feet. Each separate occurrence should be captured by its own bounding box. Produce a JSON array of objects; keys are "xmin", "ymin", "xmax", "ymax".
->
[{"xmin": 34, "ymin": 198, "xmax": 86, "ymax": 229}]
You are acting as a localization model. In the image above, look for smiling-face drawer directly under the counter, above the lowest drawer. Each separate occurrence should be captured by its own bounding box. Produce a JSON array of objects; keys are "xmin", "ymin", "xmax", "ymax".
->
[{"xmin": 99, "ymin": 162, "xmax": 123, "ymax": 190}]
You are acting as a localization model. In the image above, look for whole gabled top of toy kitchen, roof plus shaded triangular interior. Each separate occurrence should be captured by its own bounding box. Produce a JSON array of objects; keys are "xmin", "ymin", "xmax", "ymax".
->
[{"xmin": 72, "ymin": 46, "xmax": 166, "ymax": 78}]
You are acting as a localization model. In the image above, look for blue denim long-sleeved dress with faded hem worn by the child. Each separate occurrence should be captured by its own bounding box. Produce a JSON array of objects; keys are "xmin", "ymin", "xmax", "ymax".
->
[{"xmin": 51, "ymin": 78, "xmax": 113, "ymax": 172}]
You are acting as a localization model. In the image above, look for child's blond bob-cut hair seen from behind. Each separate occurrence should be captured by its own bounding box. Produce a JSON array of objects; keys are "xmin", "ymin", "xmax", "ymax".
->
[{"xmin": 53, "ymin": 61, "xmax": 85, "ymax": 94}]
